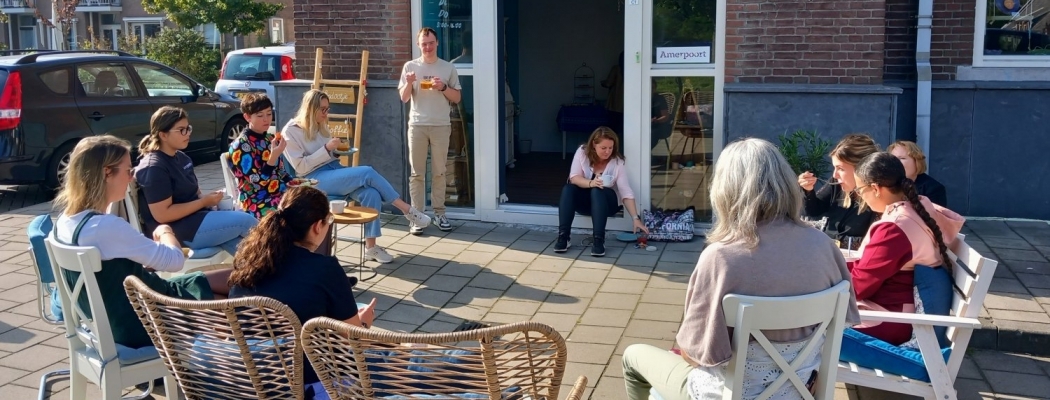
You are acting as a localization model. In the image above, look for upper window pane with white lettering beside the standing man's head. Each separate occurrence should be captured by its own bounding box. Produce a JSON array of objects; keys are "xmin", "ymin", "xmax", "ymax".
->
[{"xmin": 413, "ymin": 0, "xmax": 474, "ymax": 64}]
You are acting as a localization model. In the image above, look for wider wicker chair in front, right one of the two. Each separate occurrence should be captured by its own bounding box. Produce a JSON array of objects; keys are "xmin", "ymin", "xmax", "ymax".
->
[{"xmin": 302, "ymin": 318, "xmax": 587, "ymax": 400}]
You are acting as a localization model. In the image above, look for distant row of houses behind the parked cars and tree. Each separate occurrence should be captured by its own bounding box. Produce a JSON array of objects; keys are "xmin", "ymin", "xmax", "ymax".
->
[{"xmin": 0, "ymin": 0, "xmax": 295, "ymax": 49}]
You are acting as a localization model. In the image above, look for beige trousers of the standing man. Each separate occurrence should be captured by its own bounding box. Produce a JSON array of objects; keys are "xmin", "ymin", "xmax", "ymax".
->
[{"xmin": 408, "ymin": 125, "xmax": 453, "ymax": 215}]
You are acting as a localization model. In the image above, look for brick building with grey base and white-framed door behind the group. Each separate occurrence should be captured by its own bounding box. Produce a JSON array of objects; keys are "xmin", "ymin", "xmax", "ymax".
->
[{"xmin": 287, "ymin": 0, "xmax": 1050, "ymax": 224}]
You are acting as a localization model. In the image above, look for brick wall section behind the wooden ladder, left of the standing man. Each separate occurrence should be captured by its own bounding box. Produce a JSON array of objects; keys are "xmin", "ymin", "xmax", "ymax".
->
[{"xmin": 294, "ymin": 0, "xmax": 414, "ymax": 79}]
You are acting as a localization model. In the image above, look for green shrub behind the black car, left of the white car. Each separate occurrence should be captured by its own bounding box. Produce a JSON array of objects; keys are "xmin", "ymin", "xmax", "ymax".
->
[{"xmin": 146, "ymin": 27, "xmax": 223, "ymax": 87}]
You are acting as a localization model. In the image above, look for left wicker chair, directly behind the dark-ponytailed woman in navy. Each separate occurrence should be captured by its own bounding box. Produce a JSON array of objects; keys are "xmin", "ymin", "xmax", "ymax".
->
[{"xmin": 124, "ymin": 276, "xmax": 303, "ymax": 400}]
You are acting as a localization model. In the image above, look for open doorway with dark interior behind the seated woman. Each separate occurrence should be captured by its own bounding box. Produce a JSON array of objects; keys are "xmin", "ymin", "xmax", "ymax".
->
[{"xmin": 500, "ymin": 0, "xmax": 624, "ymax": 207}]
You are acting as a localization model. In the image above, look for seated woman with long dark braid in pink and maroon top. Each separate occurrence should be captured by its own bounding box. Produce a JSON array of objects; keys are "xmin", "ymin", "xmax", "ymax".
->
[{"xmin": 849, "ymin": 152, "xmax": 963, "ymax": 344}]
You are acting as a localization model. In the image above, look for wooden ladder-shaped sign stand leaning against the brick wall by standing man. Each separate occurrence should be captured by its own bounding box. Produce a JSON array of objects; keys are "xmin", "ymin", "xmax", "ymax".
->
[{"xmin": 310, "ymin": 47, "xmax": 369, "ymax": 167}]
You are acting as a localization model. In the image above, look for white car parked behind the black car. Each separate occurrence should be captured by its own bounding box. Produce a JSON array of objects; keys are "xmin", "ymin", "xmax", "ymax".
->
[{"xmin": 215, "ymin": 44, "xmax": 295, "ymax": 107}]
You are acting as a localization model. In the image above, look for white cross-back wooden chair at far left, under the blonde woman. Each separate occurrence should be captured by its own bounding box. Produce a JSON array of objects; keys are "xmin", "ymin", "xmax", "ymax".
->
[{"xmin": 44, "ymin": 237, "xmax": 179, "ymax": 400}]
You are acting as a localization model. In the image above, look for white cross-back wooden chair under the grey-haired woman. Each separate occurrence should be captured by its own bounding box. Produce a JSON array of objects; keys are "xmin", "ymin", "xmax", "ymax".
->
[{"xmin": 649, "ymin": 280, "xmax": 849, "ymax": 400}]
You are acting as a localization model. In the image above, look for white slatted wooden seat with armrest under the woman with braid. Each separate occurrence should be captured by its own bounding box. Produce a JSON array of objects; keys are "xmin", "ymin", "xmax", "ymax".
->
[{"xmin": 839, "ymin": 235, "xmax": 999, "ymax": 400}]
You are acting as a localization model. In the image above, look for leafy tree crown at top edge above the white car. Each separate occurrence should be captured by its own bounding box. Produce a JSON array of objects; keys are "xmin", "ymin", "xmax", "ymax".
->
[{"xmin": 142, "ymin": 0, "xmax": 285, "ymax": 35}]
